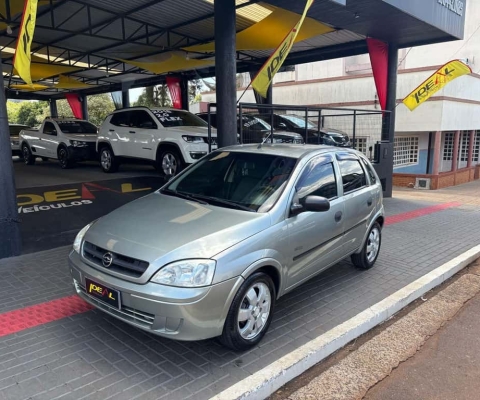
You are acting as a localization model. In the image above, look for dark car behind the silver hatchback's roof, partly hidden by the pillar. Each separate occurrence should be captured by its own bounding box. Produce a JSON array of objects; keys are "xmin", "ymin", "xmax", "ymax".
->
[{"xmin": 197, "ymin": 112, "xmax": 303, "ymax": 144}]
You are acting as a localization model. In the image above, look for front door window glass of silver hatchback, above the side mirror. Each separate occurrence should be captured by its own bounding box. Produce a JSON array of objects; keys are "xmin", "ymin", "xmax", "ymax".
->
[{"xmin": 296, "ymin": 157, "xmax": 338, "ymax": 201}]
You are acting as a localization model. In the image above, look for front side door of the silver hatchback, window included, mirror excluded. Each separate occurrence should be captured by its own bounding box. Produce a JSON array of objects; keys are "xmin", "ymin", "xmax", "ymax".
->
[{"xmin": 287, "ymin": 155, "xmax": 344, "ymax": 288}]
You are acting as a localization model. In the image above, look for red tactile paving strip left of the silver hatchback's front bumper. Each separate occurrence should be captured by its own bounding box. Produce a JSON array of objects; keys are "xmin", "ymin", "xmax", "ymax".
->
[{"xmin": 0, "ymin": 295, "xmax": 93, "ymax": 337}]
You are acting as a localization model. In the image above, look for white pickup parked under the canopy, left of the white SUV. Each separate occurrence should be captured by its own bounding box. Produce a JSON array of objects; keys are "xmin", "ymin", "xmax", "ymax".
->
[{"xmin": 20, "ymin": 117, "xmax": 98, "ymax": 168}]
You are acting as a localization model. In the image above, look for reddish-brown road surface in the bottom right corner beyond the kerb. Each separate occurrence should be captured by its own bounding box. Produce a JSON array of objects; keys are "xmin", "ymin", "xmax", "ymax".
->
[{"xmin": 364, "ymin": 266, "xmax": 480, "ymax": 400}]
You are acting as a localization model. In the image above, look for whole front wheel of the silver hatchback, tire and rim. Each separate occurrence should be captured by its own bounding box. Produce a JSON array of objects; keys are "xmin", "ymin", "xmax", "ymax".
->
[{"xmin": 219, "ymin": 272, "xmax": 276, "ymax": 351}]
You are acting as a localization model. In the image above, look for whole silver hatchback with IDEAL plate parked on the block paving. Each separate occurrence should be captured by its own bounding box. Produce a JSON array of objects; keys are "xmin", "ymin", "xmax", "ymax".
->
[{"xmin": 69, "ymin": 145, "xmax": 384, "ymax": 350}]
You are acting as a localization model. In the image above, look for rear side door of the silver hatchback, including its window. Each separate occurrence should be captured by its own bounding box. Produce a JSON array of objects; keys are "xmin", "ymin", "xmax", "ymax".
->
[{"xmin": 336, "ymin": 152, "xmax": 375, "ymax": 253}]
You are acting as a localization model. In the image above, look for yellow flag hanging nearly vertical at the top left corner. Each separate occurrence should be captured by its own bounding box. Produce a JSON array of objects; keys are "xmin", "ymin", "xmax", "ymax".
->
[{"xmin": 13, "ymin": 0, "xmax": 38, "ymax": 85}]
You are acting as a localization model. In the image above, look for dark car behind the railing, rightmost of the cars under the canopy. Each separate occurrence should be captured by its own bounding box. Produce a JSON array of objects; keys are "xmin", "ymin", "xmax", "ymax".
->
[{"xmin": 258, "ymin": 114, "xmax": 352, "ymax": 147}]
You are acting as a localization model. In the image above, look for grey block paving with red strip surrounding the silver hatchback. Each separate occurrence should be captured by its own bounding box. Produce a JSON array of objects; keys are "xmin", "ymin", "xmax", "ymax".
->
[{"xmin": 0, "ymin": 160, "xmax": 480, "ymax": 400}]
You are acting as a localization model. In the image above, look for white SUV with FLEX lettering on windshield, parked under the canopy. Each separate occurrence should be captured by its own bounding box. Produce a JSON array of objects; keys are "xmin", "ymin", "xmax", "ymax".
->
[{"xmin": 97, "ymin": 107, "xmax": 217, "ymax": 176}]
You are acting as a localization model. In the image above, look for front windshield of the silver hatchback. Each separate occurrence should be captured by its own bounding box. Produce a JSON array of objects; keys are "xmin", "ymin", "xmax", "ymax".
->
[{"xmin": 161, "ymin": 151, "xmax": 297, "ymax": 212}]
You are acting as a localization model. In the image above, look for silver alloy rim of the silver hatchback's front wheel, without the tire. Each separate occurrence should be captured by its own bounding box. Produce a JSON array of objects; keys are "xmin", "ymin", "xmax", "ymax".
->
[{"xmin": 238, "ymin": 282, "xmax": 272, "ymax": 340}]
